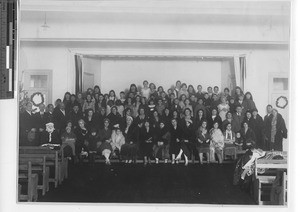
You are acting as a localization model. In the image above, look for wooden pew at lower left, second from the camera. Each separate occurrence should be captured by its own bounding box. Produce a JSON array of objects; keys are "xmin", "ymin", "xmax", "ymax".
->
[{"xmin": 19, "ymin": 155, "xmax": 50, "ymax": 195}]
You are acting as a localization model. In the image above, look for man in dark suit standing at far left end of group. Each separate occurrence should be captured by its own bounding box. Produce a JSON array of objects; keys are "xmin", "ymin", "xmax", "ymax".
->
[{"xmin": 19, "ymin": 102, "xmax": 38, "ymax": 146}]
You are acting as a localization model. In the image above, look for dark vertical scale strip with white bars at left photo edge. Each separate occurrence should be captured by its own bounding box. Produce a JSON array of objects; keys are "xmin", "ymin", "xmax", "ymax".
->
[{"xmin": 0, "ymin": 0, "xmax": 17, "ymax": 99}]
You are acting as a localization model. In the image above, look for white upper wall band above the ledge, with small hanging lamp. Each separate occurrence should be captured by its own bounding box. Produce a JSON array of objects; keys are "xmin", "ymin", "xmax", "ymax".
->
[{"xmin": 20, "ymin": 11, "xmax": 289, "ymax": 42}]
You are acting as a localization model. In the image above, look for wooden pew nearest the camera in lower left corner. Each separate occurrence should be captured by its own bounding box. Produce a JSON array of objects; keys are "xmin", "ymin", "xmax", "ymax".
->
[{"xmin": 19, "ymin": 161, "xmax": 38, "ymax": 202}]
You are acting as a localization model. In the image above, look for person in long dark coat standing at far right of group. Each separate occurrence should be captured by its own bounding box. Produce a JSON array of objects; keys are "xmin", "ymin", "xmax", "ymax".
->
[{"xmin": 266, "ymin": 109, "xmax": 287, "ymax": 151}]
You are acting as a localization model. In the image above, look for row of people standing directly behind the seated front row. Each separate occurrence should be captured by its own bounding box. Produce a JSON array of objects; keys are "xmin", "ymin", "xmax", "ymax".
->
[{"xmin": 20, "ymin": 103, "xmax": 287, "ymax": 151}]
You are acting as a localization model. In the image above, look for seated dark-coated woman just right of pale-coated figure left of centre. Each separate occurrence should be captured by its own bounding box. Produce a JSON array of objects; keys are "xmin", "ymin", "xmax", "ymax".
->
[{"xmin": 121, "ymin": 116, "xmax": 138, "ymax": 163}]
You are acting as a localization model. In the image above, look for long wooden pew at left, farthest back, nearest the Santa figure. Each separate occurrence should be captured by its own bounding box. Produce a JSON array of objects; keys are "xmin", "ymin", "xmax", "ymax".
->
[{"xmin": 19, "ymin": 146, "xmax": 68, "ymax": 187}]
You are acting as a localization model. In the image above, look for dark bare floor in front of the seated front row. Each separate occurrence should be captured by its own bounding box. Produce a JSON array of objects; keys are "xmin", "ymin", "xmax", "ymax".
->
[{"xmin": 39, "ymin": 163, "xmax": 255, "ymax": 205}]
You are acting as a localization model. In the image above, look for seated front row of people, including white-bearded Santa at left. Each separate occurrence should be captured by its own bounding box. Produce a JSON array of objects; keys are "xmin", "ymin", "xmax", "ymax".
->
[{"xmin": 22, "ymin": 116, "xmax": 255, "ymax": 165}]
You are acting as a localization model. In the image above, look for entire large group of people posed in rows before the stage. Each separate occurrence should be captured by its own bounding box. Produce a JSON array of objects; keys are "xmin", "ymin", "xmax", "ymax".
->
[{"xmin": 20, "ymin": 80, "xmax": 287, "ymax": 165}]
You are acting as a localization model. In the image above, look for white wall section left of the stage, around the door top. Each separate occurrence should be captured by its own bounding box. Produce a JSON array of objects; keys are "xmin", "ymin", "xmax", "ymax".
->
[{"xmin": 19, "ymin": 42, "xmax": 75, "ymax": 102}]
